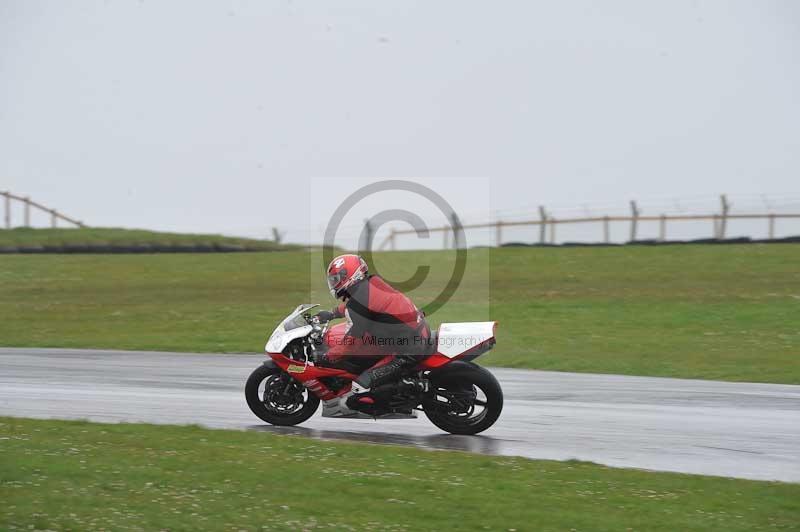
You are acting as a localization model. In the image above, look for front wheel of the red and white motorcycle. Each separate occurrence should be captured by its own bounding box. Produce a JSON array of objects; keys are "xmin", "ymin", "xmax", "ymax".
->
[{"xmin": 244, "ymin": 365, "xmax": 319, "ymax": 425}]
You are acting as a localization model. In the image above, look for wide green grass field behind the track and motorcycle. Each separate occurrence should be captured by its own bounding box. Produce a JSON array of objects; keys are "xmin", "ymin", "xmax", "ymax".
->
[{"xmin": 0, "ymin": 244, "xmax": 800, "ymax": 384}]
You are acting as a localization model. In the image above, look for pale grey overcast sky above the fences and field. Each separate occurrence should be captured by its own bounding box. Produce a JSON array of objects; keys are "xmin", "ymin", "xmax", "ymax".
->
[{"xmin": 0, "ymin": 0, "xmax": 800, "ymax": 245}]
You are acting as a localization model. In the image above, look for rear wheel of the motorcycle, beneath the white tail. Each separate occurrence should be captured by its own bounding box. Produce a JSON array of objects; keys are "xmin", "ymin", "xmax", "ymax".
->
[{"xmin": 423, "ymin": 364, "xmax": 503, "ymax": 434}]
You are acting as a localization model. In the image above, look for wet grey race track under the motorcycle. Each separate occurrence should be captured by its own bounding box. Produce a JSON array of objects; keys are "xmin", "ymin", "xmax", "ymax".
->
[{"xmin": 0, "ymin": 348, "xmax": 800, "ymax": 482}]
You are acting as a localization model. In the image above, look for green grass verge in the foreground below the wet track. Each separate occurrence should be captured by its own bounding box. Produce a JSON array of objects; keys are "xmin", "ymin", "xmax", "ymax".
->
[{"xmin": 0, "ymin": 418, "xmax": 800, "ymax": 531}]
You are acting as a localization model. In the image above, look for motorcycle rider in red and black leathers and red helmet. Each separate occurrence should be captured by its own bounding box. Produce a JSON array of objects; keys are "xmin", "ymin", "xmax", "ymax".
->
[{"xmin": 317, "ymin": 255, "xmax": 431, "ymax": 402}]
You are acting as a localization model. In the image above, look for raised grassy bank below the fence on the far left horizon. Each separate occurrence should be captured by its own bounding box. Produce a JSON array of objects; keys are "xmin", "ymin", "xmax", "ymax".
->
[{"xmin": 0, "ymin": 227, "xmax": 297, "ymax": 251}]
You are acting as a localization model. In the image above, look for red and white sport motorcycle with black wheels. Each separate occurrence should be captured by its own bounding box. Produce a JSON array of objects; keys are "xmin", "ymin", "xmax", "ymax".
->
[{"xmin": 245, "ymin": 304, "xmax": 503, "ymax": 434}]
